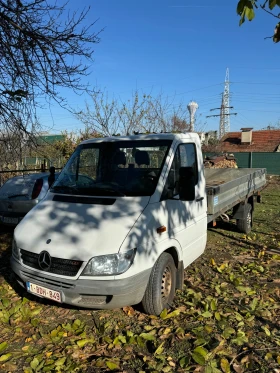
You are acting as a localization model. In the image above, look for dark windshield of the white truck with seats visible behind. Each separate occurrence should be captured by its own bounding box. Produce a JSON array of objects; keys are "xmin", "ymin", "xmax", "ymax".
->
[{"xmin": 51, "ymin": 140, "xmax": 172, "ymax": 196}]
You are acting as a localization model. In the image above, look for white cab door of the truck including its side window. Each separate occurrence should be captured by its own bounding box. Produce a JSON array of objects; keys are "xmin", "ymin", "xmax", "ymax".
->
[{"xmin": 162, "ymin": 143, "xmax": 207, "ymax": 267}]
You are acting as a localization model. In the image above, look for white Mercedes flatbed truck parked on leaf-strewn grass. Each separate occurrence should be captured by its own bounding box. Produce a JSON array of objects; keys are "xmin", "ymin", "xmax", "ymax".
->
[{"xmin": 11, "ymin": 133, "xmax": 266, "ymax": 315}]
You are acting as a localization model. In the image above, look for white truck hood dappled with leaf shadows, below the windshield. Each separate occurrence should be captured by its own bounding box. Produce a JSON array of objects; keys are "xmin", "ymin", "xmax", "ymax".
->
[{"xmin": 14, "ymin": 193, "xmax": 150, "ymax": 261}]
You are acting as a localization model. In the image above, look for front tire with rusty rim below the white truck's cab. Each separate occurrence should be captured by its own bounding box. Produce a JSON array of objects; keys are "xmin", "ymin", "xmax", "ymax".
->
[{"xmin": 142, "ymin": 253, "xmax": 176, "ymax": 316}]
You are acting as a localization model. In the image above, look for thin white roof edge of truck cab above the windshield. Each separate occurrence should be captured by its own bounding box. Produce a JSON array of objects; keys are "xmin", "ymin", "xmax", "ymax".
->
[{"xmin": 81, "ymin": 132, "xmax": 198, "ymax": 144}]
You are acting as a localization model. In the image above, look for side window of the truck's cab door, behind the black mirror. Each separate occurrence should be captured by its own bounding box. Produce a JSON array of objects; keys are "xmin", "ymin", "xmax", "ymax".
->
[{"xmin": 161, "ymin": 144, "xmax": 198, "ymax": 200}]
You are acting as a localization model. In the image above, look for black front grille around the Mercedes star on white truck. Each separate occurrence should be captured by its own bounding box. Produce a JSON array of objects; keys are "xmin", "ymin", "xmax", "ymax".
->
[{"xmin": 20, "ymin": 249, "xmax": 83, "ymax": 277}]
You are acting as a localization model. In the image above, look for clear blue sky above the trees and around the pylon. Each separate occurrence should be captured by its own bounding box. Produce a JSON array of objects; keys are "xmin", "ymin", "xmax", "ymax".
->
[{"xmin": 40, "ymin": 0, "xmax": 280, "ymax": 133}]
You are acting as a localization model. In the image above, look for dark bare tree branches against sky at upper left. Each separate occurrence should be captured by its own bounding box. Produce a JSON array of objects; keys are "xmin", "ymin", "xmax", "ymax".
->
[{"xmin": 0, "ymin": 0, "xmax": 100, "ymax": 161}]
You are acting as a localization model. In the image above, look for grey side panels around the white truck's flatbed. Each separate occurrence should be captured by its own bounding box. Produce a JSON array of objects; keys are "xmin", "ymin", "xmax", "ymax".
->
[{"xmin": 206, "ymin": 169, "xmax": 266, "ymax": 215}]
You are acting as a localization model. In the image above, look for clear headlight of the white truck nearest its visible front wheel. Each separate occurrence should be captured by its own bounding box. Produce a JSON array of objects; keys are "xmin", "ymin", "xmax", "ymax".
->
[{"xmin": 82, "ymin": 249, "xmax": 136, "ymax": 276}]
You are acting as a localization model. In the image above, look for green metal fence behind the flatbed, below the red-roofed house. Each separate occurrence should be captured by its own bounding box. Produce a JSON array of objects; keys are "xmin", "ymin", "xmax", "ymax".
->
[{"xmin": 203, "ymin": 152, "xmax": 280, "ymax": 175}]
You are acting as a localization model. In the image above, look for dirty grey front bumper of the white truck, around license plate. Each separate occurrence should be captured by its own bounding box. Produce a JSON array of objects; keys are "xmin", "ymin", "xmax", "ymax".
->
[{"xmin": 11, "ymin": 257, "xmax": 151, "ymax": 309}]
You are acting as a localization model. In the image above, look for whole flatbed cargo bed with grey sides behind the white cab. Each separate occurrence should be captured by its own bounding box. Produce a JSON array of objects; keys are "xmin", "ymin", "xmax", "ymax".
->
[{"xmin": 205, "ymin": 168, "xmax": 266, "ymax": 223}]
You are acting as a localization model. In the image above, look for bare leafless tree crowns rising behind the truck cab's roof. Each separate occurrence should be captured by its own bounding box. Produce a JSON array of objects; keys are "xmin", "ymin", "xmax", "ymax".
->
[{"xmin": 76, "ymin": 90, "xmax": 205, "ymax": 136}]
